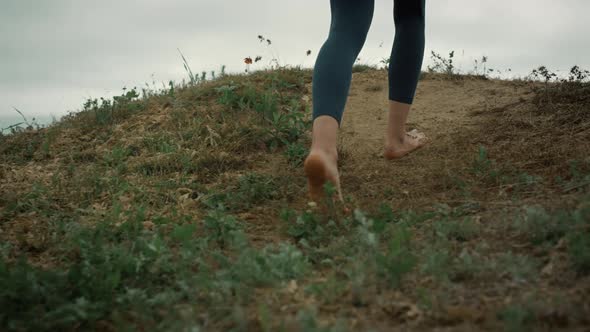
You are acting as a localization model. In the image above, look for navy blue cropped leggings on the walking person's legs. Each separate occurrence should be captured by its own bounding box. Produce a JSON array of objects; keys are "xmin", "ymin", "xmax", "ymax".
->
[{"xmin": 313, "ymin": 0, "xmax": 425, "ymax": 124}]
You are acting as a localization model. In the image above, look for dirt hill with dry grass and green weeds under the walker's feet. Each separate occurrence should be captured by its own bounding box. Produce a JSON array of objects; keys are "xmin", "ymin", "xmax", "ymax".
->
[{"xmin": 0, "ymin": 69, "xmax": 590, "ymax": 331}]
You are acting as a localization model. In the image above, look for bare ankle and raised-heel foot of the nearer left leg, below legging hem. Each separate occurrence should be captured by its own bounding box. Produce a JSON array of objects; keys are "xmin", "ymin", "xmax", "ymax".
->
[{"xmin": 303, "ymin": 115, "xmax": 343, "ymax": 202}]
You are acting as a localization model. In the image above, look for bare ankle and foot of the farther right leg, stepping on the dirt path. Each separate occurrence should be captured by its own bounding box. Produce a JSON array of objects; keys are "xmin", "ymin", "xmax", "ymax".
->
[{"xmin": 384, "ymin": 100, "xmax": 426, "ymax": 159}]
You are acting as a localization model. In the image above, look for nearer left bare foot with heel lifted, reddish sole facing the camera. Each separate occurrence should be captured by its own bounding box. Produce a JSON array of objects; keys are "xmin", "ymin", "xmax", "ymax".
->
[{"xmin": 303, "ymin": 150, "xmax": 344, "ymax": 202}]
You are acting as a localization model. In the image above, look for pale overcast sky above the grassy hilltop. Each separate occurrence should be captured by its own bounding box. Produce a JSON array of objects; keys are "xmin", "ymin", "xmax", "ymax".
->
[{"xmin": 0, "ymin": 0, "xmax": 590, "ymax": 128}]
